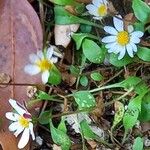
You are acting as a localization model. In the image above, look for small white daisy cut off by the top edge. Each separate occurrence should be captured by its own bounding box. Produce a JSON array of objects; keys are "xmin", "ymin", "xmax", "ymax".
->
[{"xmin": 86, "ymin": 0, "xmax": 108, "ymax": 20}]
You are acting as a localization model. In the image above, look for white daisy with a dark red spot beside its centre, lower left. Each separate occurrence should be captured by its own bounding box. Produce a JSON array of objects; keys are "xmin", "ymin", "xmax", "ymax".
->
[{"xmin": 5, "ymin": 99, "xmax": 35, "ymax": 149}]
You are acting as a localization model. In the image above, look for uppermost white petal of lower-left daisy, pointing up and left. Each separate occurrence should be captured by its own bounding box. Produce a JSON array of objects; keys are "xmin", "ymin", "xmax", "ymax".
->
[{"xmin": 9, "ymin": 99, "xmax": 27, "ymax": 115}]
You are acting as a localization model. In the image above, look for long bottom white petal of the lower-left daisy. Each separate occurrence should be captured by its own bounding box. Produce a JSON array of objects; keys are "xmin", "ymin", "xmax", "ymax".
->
[{"xmin": 18, "ymin": 128, "xmax": 30, "ymax": 149}]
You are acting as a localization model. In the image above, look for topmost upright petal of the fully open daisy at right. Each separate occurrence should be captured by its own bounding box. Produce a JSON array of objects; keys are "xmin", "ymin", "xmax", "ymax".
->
[{"xmin": 113, "ymin": 15, "xmax": 124, "ymax": 31}]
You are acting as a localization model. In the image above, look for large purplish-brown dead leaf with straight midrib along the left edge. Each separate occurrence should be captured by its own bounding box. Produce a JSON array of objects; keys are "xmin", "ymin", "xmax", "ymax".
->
[{"xmin": 0, "ymin": 0, "xmax": 43, "ymax": 150}]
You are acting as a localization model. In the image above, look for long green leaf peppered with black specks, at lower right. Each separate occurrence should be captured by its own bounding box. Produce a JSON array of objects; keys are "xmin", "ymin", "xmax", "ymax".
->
[{"xmin": 123, "ymin": 93, "xmax": 145, "ymax": 131}]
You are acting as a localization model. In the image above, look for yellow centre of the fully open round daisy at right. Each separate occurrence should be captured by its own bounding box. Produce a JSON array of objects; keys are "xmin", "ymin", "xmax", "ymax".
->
[{"xmin": 117, "ymin": 31, "xmax": 130, "ymax": 46}]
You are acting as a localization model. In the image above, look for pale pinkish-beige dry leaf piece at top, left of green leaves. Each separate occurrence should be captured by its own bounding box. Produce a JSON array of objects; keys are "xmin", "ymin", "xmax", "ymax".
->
[{"xmin": 54, "ymin": 24, "xmax": 79, "ymax": 48}]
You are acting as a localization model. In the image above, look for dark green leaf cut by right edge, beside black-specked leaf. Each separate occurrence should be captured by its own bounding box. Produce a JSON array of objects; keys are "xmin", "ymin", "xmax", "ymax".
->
[{"xmin": 139, "ymin": 92, "xmax": 150, "ymax": 121}]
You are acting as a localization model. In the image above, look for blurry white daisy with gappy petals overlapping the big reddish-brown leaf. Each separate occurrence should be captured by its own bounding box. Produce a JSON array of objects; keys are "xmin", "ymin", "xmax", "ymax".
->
[{"xmin": 24, "ymin": 46, "xmax": 61, "ymax": 84}]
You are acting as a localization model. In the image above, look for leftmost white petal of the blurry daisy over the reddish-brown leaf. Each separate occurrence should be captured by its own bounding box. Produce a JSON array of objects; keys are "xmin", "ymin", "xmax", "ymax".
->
[{"xmin": 24, "ymin": 64, "xmax": 41, "ymax": 75}]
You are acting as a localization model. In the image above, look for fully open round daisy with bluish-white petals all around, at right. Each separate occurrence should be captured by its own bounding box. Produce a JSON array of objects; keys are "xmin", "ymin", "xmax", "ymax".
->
[{"xmin": 102, "ymin": 15, "xmax": 144, "ymax": 60}]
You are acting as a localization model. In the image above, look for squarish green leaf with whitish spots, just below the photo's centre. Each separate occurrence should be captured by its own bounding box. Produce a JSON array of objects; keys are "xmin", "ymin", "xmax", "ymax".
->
[{"xmin": 73, "ymin": 91, "xmax": 96, "ymax": 110}]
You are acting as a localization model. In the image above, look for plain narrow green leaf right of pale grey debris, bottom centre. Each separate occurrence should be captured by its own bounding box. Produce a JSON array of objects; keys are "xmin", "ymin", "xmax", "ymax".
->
[{"xmin": 80, "ymin": 120, "xmax": 97, "ymax": 140}]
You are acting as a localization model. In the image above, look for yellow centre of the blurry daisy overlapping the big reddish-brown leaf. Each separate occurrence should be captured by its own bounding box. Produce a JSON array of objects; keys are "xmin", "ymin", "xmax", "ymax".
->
[{"xmin": 36, "ymin": 59, "xmax": 52, "ymax": 71}]
